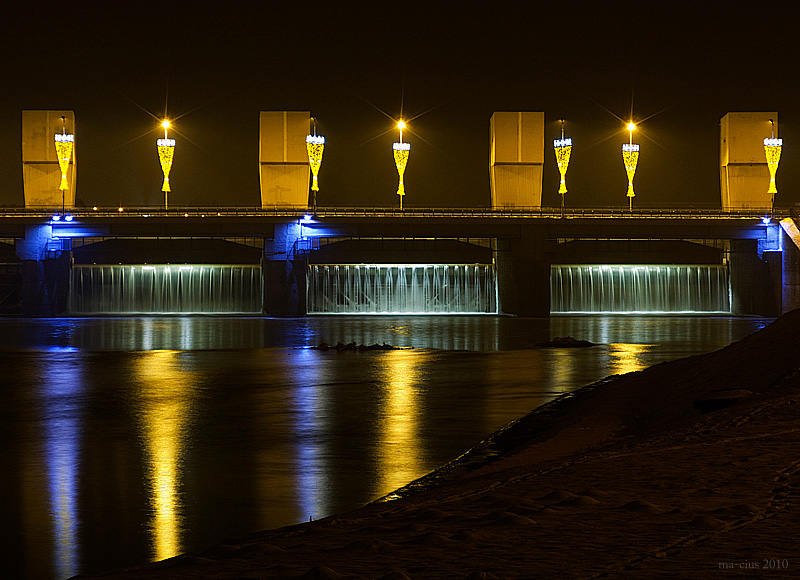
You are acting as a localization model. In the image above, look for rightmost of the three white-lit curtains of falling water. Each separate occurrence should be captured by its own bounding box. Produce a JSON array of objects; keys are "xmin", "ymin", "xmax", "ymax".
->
[{"xmin": 550, "ymin": 265, "xmax": 731, "ymax": 313}]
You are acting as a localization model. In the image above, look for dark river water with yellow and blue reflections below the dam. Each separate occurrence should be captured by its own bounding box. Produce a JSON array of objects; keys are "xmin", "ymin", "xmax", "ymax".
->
[{"xmin": 0, "ymin": 316, "xmax": 770, "ymax": 580}]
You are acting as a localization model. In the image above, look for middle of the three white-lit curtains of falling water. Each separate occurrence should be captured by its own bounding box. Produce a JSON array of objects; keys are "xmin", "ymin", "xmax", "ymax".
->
[{"xmin": 307, "ymin": 264, "xmax": 497, "ymax": 314}]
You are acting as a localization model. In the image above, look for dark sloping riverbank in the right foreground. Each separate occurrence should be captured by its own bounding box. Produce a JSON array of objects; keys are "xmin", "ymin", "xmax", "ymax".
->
[{"xmin": 86, "ymin": 311, "xmax": 800, "ymax": 580}]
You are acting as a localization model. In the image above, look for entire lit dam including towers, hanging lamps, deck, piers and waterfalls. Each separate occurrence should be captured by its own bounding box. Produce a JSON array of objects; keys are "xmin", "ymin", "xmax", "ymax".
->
[{"xmin": 0, "ymin": 111, "xmax": 800, "ymax": 316}]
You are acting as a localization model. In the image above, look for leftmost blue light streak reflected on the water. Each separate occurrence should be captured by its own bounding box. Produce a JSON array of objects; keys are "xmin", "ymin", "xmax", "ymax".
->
[{"xmin": 40, "ymin": 356, "xmax": 84, "ymax": 578}]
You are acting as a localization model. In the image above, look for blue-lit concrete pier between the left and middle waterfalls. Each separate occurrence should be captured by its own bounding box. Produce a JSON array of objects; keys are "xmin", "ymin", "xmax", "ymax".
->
[{"xmin": 263, "ymin": 223, "xmax": 307, "ymax": 316}]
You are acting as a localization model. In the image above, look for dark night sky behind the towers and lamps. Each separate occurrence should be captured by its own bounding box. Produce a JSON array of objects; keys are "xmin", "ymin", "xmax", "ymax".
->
[{"xmin": 0, "ymin": 1, "xmax": 800, "ymax": 207}]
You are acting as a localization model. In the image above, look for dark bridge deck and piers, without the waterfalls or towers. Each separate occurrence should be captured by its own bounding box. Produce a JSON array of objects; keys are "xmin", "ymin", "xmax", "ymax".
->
[{"xmin": 0, "ymin": 207, "xmax": 800, "ymax": 316}]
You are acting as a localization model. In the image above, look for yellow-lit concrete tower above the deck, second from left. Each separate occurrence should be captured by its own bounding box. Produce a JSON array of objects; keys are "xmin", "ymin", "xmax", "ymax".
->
[{"xmin": 258, "ymin": 111, "xmax": 311, "ymax": 208}]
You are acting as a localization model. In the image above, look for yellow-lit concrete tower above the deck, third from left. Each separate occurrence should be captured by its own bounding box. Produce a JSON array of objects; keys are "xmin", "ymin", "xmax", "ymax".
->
[{"xmin": 489, "ymin": 111, "xmax": 544, "ymax": 209}]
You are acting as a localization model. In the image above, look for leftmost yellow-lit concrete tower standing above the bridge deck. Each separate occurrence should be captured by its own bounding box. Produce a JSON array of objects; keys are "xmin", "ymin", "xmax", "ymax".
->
[{"xmin": 22, "ymin": 111, "xmax": 77, "ymax": 209}]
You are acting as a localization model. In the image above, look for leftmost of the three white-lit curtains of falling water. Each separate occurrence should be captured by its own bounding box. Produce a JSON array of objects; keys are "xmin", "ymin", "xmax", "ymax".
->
[{"xmin": 70, "ymin": 264, "xmax": 263, "ymax": 314}]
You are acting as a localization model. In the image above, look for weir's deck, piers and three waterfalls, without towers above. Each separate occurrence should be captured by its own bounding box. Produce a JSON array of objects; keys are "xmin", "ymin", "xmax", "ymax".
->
[{"xmin": 0, "ymin": 208, "xmax": 800, "ymax": 316}]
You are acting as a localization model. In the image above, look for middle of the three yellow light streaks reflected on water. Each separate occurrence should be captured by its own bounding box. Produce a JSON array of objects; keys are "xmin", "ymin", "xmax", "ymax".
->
[{"xmin": 376, "ymin": 350, "xmax": 423, "ymax": 495}]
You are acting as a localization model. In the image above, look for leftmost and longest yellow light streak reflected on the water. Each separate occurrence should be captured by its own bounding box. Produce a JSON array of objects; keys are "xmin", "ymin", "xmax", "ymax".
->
[{"xmin": 135, "ymin": 351, "xmax": 196, "ymax": 560}]
